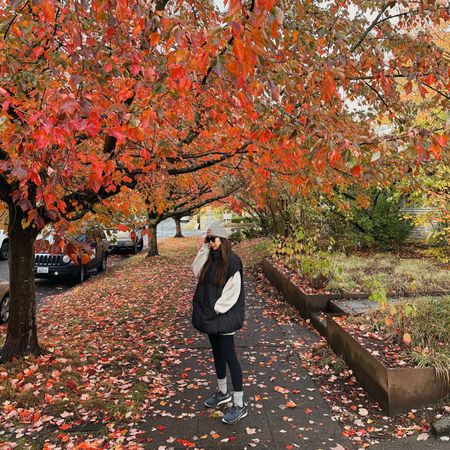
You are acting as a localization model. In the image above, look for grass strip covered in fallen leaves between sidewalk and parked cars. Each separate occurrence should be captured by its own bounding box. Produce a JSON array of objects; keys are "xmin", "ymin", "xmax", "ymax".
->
[{"xmin": 0, "ymin": 239, "xmax": 194, "ymax": 449}]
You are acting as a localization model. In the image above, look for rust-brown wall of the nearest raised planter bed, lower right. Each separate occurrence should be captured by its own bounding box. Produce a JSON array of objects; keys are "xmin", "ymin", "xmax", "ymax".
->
[{"xmin": 327, "ymin": 316, "xmax": 449, "ymax": 416}]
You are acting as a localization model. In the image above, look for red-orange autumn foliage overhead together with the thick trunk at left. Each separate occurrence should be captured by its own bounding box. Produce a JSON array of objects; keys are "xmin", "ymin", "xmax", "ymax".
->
[{"xmin": 0, "ymin": 0, "xmax": 449, "ymax": 356}]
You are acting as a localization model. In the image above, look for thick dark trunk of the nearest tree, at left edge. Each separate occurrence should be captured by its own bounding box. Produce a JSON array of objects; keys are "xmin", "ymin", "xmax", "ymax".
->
[{"xmin": 0, "ymin": 205, "xmax": 41, "ymax": 361}]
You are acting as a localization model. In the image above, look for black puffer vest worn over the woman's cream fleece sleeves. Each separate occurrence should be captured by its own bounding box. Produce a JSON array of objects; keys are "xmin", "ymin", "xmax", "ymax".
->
[{"xmin": 192, "ymin": 250, "xmax": 245, "ymax": 334}]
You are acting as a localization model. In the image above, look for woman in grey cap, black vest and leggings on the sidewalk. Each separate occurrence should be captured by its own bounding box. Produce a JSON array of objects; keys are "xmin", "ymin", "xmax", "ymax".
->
[{"xmin": 192, "ymin": 226, "xmax": 247, "ymax": 424}]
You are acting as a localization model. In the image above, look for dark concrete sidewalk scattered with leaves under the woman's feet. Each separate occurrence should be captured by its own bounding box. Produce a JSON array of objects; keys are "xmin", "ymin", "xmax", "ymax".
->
[{"xmin": 143, "ymin": 280, "xmax": 448, "ymax": 450}]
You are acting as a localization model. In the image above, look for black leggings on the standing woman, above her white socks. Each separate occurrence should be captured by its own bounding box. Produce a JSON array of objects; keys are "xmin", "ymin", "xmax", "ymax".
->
[{"xmin": 208, "ymin": 334, "xmax": 242, "ymax": 392}]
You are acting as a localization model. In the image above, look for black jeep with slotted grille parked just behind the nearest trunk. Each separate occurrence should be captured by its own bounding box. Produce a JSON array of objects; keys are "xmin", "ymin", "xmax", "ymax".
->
[{"xmin": 34, "ymin": 228, "xmax": 108, "ymax": 283}]
